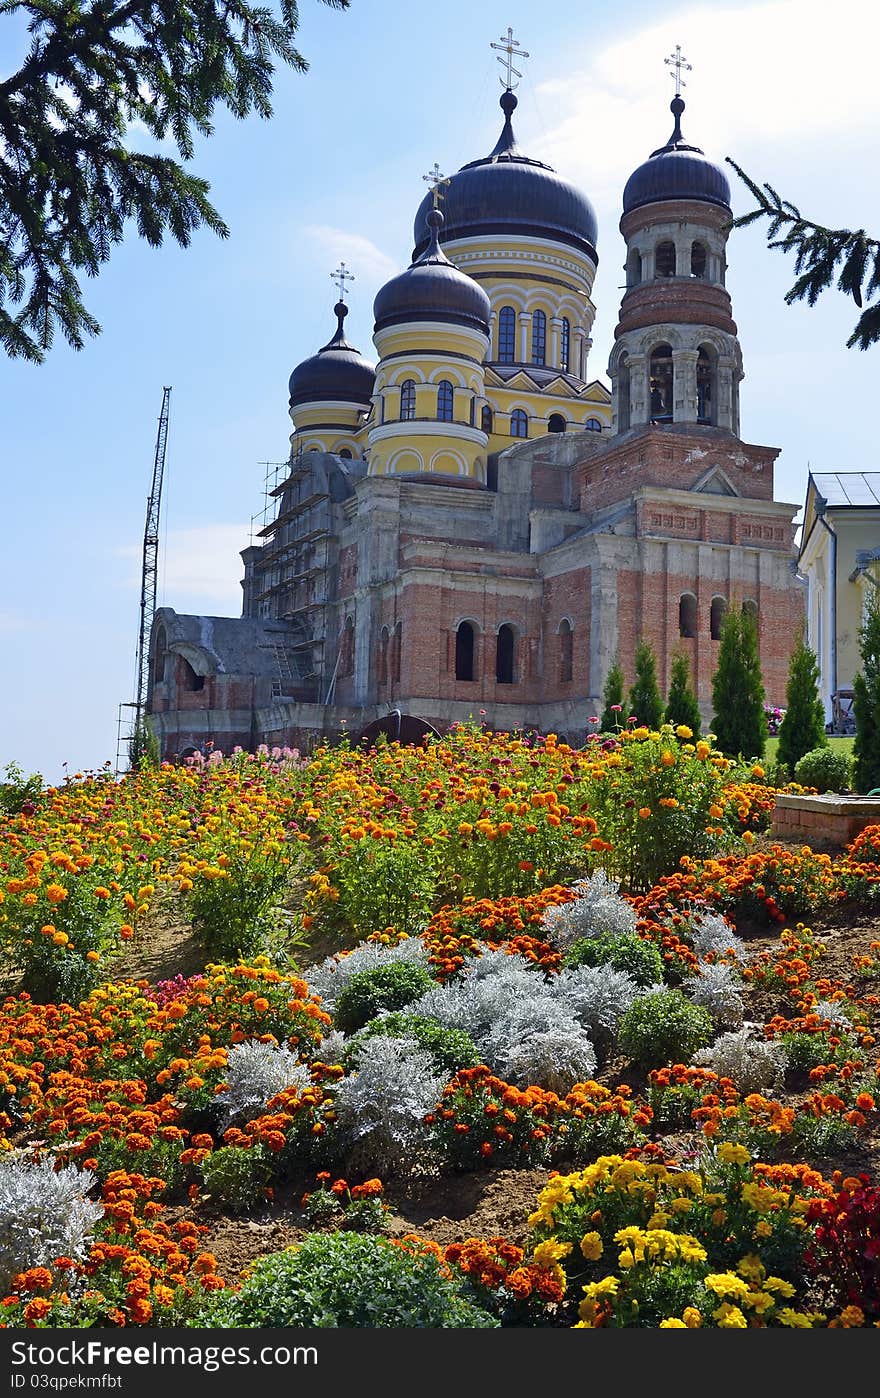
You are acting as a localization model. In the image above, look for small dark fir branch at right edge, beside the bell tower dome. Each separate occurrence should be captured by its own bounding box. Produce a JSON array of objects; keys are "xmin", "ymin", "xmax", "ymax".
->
[{"xmin": 728, "ymin": 157, "xmax": 880, "ymax": 350}]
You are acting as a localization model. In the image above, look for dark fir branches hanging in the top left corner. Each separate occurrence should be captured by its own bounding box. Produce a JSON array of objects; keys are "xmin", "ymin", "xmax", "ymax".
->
[{"xmin": 0, "ymin": 0, "xmax": 348, "ymax": 363}]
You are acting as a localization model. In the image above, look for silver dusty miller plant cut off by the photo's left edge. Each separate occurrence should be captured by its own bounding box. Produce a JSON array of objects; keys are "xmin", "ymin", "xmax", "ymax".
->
[{"xmin": 0, "ymin": 1152, "xmax": 104, "ymax": 1295}]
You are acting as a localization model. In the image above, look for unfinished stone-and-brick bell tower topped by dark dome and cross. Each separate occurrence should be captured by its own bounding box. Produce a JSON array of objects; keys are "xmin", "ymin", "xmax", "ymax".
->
[{"xmin": 609, "ymin": 48, "xmax": 743, "ymax": 438}]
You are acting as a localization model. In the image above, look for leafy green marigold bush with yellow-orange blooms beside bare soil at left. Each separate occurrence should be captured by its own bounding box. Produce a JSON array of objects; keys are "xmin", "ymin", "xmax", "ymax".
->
[{"xmin": 187, "ymin": 846, "xmax": 288, "ymax": 962}]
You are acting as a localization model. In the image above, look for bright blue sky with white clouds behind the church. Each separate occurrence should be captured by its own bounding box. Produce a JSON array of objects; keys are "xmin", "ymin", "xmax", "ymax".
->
[{"xmin": 0, "ymin": 0, "xmax": 880, "ymax": 783}]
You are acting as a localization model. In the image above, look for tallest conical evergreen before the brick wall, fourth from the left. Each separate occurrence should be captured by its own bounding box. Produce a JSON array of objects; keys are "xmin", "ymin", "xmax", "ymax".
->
[{"xmin": 712, "ymin": 607, "xmax": 767, "ymax": 758}]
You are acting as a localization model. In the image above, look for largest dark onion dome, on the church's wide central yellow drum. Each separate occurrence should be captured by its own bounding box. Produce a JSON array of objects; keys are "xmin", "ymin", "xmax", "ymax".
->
[{"xmin": 413, "ymin": 91, "xmax": 597, "ymax": 261}]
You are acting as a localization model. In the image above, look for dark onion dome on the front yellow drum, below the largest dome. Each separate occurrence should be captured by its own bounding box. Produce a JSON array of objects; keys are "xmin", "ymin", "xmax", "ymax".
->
[{"xmin": 372, "ymin": 207, "xmax": 490, "ymax": 336}]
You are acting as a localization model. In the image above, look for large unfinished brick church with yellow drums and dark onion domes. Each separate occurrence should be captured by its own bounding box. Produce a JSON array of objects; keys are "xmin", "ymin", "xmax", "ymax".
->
[{"xmin": 147, "ymin": 34, "xmax": 804, "ymax": 758}]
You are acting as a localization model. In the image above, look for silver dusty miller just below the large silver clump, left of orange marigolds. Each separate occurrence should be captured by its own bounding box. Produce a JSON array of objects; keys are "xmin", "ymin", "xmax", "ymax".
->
[{"xmin": 334, "ymin": 1035, "xmax": 445, "ymax": 1179}]
